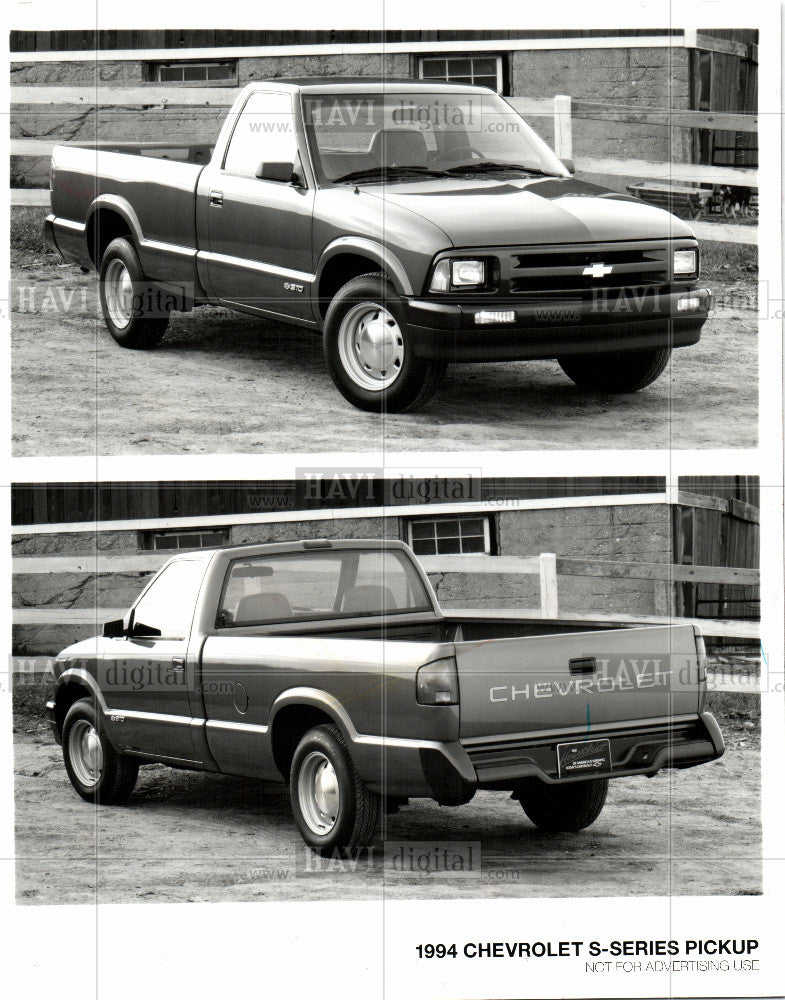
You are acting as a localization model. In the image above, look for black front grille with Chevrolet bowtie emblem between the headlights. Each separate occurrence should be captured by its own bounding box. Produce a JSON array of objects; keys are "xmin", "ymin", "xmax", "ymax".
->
[{"xmin": 505, "ymin": 242, "xmax": 672, "ymax": 298}]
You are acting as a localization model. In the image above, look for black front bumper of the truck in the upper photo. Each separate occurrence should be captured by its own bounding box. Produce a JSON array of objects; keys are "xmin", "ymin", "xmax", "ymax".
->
[{"xmin": 404, "ymin": 288, "xmax": 711, "ymax": 361}]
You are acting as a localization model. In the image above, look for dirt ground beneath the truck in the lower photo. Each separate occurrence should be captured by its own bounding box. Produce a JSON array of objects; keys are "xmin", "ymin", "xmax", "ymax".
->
[{"xmin": 15, "ymin": 720, "xmax": 761, "ymax": 904}]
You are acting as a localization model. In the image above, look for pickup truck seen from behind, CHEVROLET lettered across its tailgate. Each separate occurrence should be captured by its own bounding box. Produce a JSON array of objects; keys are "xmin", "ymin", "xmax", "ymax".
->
[{"xmin": 47, "ymin": 540, "xmax": 724, "ymax": 853}]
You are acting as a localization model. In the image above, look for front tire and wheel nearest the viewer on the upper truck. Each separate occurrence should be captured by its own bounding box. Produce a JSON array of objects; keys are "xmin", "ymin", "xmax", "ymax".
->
[{"xmin": 323, "ymin": 273, "xmax": 447, "ymax": 413}]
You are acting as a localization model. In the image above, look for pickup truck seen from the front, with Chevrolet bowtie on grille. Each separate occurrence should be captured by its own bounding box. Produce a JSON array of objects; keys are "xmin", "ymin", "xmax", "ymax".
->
[{"xmin": 45, "ymin": 78, "xmax": 711, "ymax": 412}]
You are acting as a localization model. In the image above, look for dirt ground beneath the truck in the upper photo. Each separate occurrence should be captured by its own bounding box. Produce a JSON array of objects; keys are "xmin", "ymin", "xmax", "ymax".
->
[{"xmin": 10, "ymin": 258, "xmax": 758, "ymax": 456}]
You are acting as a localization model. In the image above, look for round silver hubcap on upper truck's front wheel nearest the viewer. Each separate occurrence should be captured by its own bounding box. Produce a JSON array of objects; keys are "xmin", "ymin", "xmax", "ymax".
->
[{"xmin": 338, "ymin": 302, "xmax": 405, "ymax": 392}]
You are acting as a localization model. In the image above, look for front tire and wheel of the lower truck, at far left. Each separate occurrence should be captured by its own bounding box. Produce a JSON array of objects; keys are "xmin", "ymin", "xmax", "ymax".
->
[{"xmin": 62, "ymin": 698, "xmax": 139, "ymax": 806}]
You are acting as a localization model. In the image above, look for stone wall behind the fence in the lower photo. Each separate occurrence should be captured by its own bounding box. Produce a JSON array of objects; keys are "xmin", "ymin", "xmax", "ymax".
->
[{"xmin": 13, "ymin": 504, "xmax": 672, "ymax": 654}]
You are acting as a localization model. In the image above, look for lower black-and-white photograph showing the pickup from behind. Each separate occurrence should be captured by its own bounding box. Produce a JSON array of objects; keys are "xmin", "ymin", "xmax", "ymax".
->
[{"xmin": 13, "ymin": 471, "xmax": 761, "ymax": 904}]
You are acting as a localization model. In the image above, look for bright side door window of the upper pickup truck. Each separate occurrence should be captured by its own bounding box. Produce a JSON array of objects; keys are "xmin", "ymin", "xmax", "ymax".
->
[{"xmin": 224, "ymin": 94, "xmax": 297, "ymax": 177}]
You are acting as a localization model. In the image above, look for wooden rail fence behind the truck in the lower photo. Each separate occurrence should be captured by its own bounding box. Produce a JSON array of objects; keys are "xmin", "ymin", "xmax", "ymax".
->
[{"xmin": 13, "ymin": 552, "xmax": 760, "ymax": 639}]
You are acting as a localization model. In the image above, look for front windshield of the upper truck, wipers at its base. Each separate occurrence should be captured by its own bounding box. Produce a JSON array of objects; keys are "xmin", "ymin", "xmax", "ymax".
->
[{"xmin": 303, "ymin": 91, "xmax": 569, "ymax": 182}]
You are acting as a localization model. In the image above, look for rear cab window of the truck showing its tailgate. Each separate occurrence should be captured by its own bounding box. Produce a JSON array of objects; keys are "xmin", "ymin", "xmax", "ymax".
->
[{"xmin": 216, "ymin": 549, "xmax": 432, "ymax": 628}]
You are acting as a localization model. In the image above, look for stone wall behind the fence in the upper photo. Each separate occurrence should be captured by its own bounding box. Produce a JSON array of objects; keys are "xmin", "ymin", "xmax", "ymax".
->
[{"xmin": 11, "ymin": 46, "xmax": 690, "ymax": 187}]
